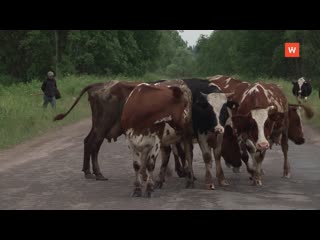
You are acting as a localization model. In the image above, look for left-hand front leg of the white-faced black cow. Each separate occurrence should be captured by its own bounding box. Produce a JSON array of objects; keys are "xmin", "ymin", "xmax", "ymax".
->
[{"xmin": 198, "ymin": 134, "xmax": 214, "ymax": 190}]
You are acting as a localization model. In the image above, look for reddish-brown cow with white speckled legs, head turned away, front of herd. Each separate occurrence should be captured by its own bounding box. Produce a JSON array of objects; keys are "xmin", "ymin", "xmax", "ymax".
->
[{"xmin": 121, "ymin": 80, "xmax": 193, "ymax": 197}]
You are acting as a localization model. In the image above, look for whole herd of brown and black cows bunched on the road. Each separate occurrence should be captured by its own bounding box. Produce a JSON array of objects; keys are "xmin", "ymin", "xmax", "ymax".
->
[{"xmin": 55, "ymin": 75, "xmax": 313, "ymax": 197}]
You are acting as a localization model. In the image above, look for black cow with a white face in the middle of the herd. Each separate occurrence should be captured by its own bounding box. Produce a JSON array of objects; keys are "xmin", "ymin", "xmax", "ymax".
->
[{"xmin": 158, "ymin": 79, "xmax": 236, "ymax": 189}]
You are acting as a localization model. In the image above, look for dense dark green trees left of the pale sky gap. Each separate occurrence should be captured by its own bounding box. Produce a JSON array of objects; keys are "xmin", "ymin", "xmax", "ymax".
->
[{"xmin": 0, "ymin": 30, "xmax": 186, "ymax": 84}]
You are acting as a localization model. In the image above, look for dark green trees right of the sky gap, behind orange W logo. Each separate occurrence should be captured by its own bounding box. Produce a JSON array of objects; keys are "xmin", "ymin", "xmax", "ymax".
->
[{"xmin": 195, "ymin": 30, "xmax": 320, "ymax": 82}]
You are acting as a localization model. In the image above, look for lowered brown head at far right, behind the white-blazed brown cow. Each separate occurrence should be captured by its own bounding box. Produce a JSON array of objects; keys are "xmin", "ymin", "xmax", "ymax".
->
[{"xmin": 288, "ymin": 105, "xmax": 305, "ymax": 145}]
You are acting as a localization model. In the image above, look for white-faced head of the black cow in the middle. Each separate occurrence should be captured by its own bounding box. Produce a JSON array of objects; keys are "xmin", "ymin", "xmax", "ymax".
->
[{"xmin": 201, "ymin": 92, "xmax": 239, "ymax": 134}]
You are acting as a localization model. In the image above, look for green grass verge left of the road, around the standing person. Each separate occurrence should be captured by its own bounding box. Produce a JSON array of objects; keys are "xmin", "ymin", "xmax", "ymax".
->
[{"xmin": 0, "ymin": 73, "xmax": 161, "ymax": 149}]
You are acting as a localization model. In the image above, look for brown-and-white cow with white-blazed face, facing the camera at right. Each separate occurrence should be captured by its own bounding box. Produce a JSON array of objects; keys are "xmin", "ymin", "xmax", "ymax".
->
[{"xmin": 209, "ymin": 76, "xmax": 290, "ymax": 185}]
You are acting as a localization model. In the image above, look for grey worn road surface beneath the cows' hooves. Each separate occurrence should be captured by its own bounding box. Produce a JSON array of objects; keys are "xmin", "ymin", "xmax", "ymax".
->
[{"xmin": 0, "ymin": 120, "xmax": 320, "ymax": 209}]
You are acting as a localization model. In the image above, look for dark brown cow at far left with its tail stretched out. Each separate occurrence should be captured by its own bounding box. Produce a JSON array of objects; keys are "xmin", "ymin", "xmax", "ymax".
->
[{"xmin": 54, "ymin": 81, "xmax": 139, "ymax": 180}]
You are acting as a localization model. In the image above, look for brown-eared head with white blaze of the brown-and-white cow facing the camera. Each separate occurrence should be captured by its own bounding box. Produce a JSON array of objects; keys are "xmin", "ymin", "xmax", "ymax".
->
[{"xmin": 232, "ymin": 106, "xmax": 284, "ymax": 151}]
